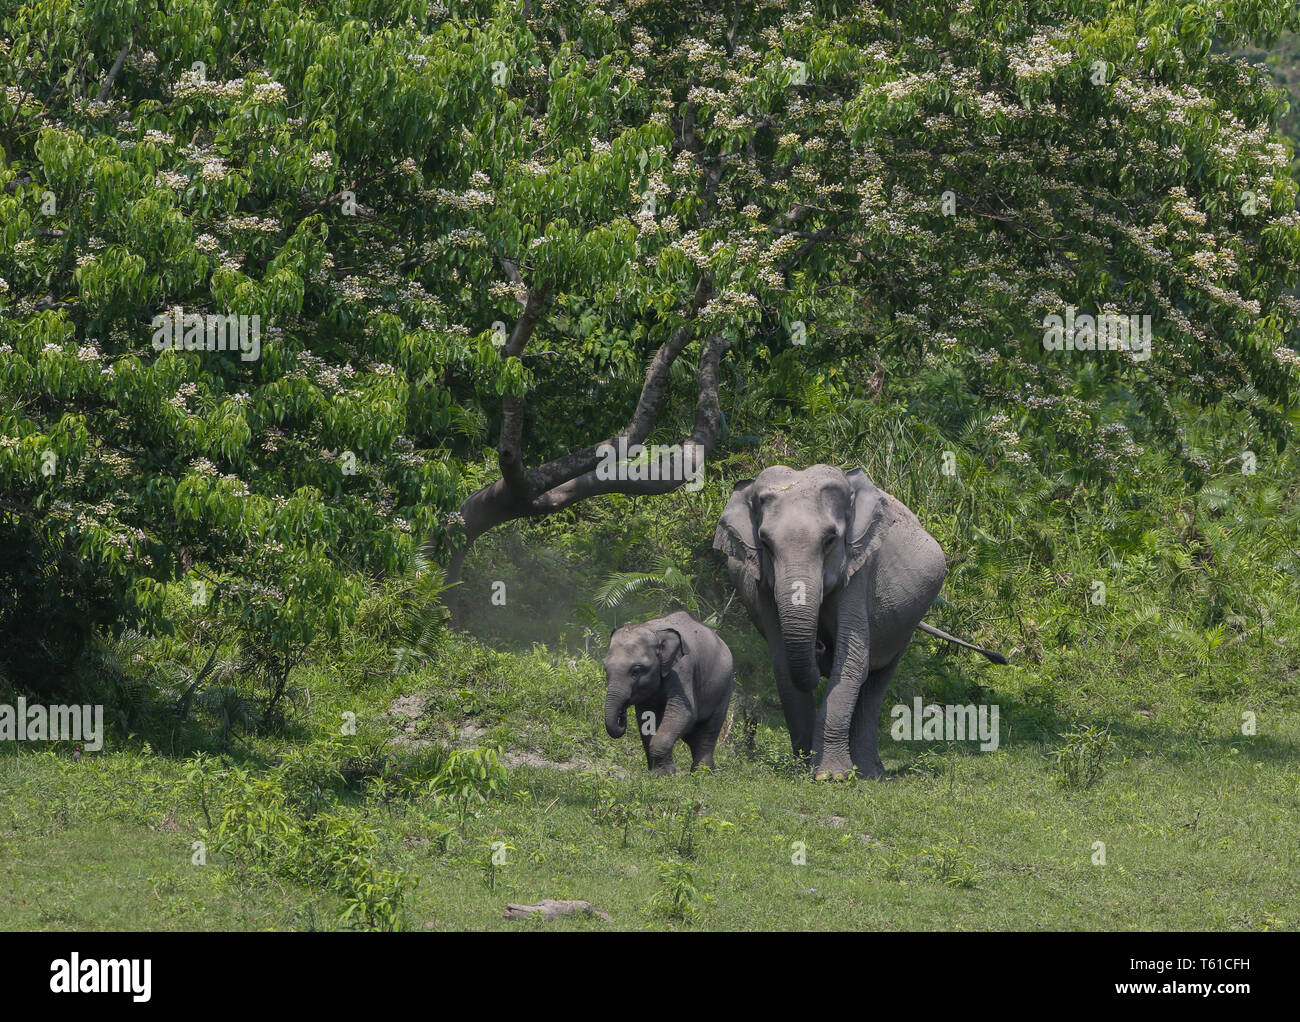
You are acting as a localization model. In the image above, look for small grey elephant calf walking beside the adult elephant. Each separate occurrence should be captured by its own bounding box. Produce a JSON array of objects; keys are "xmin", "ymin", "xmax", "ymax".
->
[{"xmin": 605, "ymin": 611, "xmax": 736, "ymax": 774}]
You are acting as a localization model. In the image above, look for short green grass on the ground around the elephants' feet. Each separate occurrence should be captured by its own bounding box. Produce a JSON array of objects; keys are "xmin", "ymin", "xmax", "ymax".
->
[{"xmin": 0, "ymin": 621, "xmax": 1300, "ymax": 930}]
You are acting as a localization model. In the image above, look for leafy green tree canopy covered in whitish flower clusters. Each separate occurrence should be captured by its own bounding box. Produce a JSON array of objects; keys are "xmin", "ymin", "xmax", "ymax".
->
[{"xmin": 0, "ymin": 0, "xmax": 1300, "ymax": 686}]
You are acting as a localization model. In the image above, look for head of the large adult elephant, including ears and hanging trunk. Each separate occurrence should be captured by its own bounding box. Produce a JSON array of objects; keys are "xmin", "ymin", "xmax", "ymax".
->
[{"xmin": 714, "ymin": 465, "xmax": 884, "ymax": 692}]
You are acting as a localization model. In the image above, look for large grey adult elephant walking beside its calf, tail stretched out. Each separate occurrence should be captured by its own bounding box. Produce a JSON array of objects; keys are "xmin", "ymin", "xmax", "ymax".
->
[{"xmin": 714, "ymin": 465, "xmax": 1006, "ymax": 780}]
